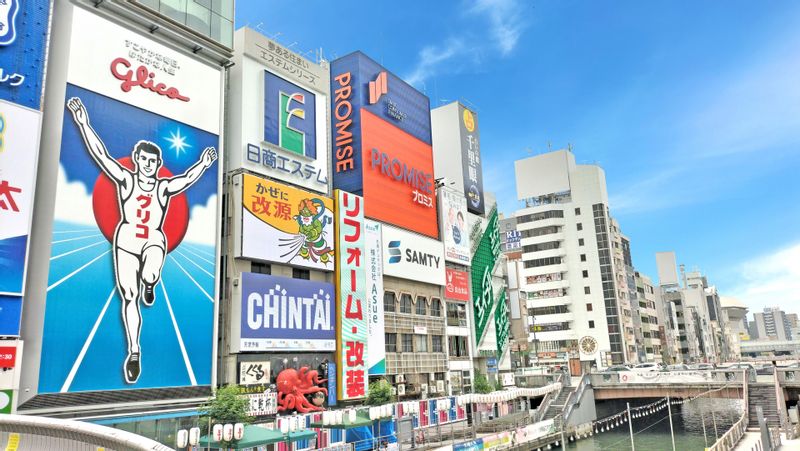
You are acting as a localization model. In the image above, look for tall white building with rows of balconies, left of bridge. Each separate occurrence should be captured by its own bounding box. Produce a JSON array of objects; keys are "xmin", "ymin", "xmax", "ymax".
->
[{"xmin": 514, "ymin": 150, "xmax": 626, "ymax": 369}]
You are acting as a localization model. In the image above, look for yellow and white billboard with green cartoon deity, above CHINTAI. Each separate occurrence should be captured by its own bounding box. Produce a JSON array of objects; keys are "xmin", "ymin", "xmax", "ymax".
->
[{"xmin": 238, "ymin": 174, "xmax": 335, "ymax": 271}]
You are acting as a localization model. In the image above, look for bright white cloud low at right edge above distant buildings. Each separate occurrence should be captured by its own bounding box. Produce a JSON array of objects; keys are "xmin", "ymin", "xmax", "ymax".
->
[{"xmin": 726, "ymin": 243, "xmax": 800, "ymax": 312}]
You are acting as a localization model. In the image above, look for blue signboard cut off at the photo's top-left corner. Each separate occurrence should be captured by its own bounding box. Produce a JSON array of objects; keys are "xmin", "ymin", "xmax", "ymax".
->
[{"xmin": 0, "ymin": 0, "xmax": 50, "ymax": 110}]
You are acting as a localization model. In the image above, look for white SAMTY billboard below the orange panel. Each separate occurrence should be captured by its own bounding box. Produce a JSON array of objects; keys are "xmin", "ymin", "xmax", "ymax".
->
[{"xmin": 382, "ymin": 224, "xmax": 445, "ymax": 285}]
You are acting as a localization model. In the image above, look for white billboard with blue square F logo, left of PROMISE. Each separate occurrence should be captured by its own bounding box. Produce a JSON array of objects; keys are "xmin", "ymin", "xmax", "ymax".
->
[{"xmin": 229, "ymin": 28, "xmax": 330, "ymax": 194}]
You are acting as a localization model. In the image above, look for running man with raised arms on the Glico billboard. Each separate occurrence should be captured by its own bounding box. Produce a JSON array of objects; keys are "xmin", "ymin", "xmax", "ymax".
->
[{"xmin": 67, "ymin": 97, "xmax": 217, "ymax": 384}]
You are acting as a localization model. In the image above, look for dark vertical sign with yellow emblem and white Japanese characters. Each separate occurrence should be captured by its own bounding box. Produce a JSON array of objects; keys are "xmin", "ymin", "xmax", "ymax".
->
[{"xmin": 458, "ymin": 103, "xmax": 485, "ymax": 215}]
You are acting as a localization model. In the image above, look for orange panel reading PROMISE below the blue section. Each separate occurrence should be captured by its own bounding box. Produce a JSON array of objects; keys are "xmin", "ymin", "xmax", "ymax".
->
[{"xmin": 360, "ymin": 109, "xmax": 439, "ymax": 239}]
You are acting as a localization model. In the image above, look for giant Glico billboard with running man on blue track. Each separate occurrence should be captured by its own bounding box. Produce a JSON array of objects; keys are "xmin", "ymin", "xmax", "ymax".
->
[{"xmin": 38, "ymin": 7, "xmax": 221, "ymax": 393}]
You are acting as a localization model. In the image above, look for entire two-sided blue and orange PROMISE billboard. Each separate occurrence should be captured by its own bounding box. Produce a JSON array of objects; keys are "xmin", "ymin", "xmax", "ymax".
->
[{"xmin": 331, "ymin": 52, "xmax": 439, "ymax": 238}]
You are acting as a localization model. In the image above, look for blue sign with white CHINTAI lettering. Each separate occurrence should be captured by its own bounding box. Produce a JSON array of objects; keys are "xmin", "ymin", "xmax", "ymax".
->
[{"xmin": 239, "ymin": 273, "xmax": 336, "ymax": 351}]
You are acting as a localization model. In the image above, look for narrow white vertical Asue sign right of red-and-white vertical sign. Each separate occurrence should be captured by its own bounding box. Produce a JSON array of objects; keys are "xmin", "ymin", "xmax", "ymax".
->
[{"xmin": 364, "ymin": 219, "xmax": 386, "ymax": 376}]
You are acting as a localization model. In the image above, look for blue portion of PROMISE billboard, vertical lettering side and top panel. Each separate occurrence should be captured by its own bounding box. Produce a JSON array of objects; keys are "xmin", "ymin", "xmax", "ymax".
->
[{"xmin": 331, "ymin": 52, "xmax": 432, "ymax": 195}]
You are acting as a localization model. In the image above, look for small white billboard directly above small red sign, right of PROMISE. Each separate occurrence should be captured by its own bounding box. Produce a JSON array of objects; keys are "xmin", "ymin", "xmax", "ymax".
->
[{"xmin": 439, "ymin": 187, "xmax": 472, "ymax": 266}]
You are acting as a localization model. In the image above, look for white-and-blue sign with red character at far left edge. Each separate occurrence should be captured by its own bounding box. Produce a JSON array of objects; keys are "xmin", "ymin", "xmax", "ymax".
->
[{"xmin": 0, "ymin": 100, "xmax": 41, "ymax": 300}]
